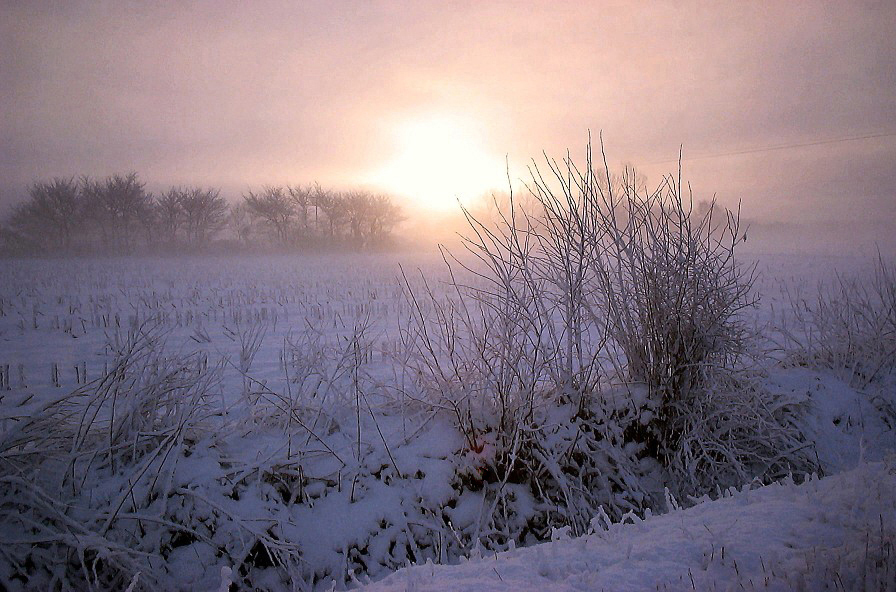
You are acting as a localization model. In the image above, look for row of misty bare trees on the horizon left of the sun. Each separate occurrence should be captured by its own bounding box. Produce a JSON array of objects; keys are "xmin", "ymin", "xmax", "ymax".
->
[{"xmin": 0, "ymin": 173, "xmax": 403, "ymax": 255}]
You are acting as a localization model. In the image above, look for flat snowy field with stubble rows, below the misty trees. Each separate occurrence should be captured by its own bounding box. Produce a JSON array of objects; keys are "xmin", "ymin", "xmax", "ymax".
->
[{"xmin": 0, "ymin": 255, "xmax": 440, "ymax": 394}]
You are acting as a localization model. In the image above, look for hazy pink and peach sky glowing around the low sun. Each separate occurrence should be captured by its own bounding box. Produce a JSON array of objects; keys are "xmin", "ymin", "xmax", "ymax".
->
[{"xmin": 0, "ymin": 1, "xmax": 896, "ymax": 250}]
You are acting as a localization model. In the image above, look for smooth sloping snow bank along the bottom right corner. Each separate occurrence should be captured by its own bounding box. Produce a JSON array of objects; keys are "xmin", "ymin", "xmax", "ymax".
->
[{"xmin": 365, "ymin": 457, "xmax": 896, "ymax": 592}]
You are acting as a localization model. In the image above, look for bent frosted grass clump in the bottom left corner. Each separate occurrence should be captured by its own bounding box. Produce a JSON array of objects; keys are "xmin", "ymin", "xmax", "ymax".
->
[{"xmin": 0, "ymin": 326, "xmax": 219, "ymax": 590}]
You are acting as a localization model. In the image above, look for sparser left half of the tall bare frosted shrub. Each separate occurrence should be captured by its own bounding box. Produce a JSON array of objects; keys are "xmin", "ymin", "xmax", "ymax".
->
[{"xmin": 403, "ymin": 165, "xmax": 632, "ymax": 536}]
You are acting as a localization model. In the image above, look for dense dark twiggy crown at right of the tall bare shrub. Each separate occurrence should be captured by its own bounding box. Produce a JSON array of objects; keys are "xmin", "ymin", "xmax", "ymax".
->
[{"xmin": 597, "ymin": 173, "xmax": 753, "ymax": 402}]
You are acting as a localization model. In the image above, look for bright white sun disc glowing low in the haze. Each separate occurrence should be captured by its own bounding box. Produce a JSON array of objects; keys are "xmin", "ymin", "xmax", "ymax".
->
[{"xmin": 369, "ymin": 114, "xmax": 507, "ymax": 210}]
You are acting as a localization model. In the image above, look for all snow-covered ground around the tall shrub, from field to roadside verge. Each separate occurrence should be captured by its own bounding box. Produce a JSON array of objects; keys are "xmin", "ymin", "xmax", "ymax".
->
[{"xmin": 0, "ymin": 254, "xmax": 896, "ymax": 590}]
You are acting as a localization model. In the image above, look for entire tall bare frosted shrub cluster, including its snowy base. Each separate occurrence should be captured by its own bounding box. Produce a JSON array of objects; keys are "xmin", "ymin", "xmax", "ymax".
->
[{"xmin": 404, "ymin": 139, "xmax": 814, "ymax": 534}]
